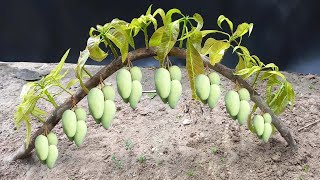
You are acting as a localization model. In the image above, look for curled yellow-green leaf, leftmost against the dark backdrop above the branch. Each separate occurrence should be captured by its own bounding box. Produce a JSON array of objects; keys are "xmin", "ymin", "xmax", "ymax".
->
[{"xmin": 87, "ymin": 36, "xmax": 108, "ymax": 62}]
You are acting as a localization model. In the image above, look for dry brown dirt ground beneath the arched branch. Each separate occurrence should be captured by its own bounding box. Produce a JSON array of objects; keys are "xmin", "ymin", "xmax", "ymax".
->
[{"xmin": 0, "ymin": 63, "xmax": 320, "ymax": 180}]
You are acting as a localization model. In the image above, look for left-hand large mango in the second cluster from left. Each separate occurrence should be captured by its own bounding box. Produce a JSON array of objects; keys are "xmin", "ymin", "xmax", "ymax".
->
[{"xmin": 62, "ymin": 109, "xmax": 77, "ymax": 137}]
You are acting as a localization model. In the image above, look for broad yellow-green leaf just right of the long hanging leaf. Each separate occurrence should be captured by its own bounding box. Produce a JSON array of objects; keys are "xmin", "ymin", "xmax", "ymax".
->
[{"xmin": 201, "ymin": 38, "xmax": 230, "ymax": 66}]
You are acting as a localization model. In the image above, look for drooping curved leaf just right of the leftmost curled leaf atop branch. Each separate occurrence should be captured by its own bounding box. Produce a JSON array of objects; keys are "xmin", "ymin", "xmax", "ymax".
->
[{"xmin": 105, "ymin": 29, "xmax": 129, "ymax": 63}]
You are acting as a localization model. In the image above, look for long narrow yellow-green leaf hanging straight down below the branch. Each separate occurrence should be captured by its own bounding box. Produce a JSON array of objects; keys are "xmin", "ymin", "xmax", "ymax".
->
[{"xmin": 186, "ymin": 35, "xmax": 204, "ymax": 99}]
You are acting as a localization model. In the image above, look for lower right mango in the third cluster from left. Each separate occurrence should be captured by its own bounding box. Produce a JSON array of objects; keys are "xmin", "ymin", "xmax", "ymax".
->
[{"xmin": 101, "ymin": 100, "xmax": 117, "ymax": 129}]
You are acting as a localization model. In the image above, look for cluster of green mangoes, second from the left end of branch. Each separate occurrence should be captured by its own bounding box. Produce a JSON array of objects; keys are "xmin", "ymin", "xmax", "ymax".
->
[{"xmin": 62, "ymin": 107, "xmax": 87, "ymax": 147}]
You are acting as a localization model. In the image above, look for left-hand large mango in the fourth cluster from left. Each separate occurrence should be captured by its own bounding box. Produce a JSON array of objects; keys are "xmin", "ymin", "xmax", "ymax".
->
[{"xmin": 116, "ymin": 68, "xmax": 132, "ymax": 99}]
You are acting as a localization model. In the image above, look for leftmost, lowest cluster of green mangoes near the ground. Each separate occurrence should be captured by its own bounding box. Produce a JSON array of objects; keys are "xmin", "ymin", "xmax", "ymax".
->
[{"xmin": 34, "ymin": 132, "xmax": 59, "ymax": 169}]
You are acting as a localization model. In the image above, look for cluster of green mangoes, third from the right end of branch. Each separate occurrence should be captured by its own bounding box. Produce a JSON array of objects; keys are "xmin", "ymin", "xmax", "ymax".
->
[{"xmin": 195, "ymin": 72, "xmax": 221, "ymax": 109}]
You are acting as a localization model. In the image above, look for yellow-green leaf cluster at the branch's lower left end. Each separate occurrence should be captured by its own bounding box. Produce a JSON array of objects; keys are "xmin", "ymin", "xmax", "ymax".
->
[{"xmin": 14, "ymin": 50, "xmax": 77, "ymax": 146}]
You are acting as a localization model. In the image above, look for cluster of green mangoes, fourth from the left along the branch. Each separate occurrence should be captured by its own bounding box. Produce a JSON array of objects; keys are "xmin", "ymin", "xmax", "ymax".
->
[{"xmin": 116, "ymin": 66, "xmax": 142, "ymax": 109}]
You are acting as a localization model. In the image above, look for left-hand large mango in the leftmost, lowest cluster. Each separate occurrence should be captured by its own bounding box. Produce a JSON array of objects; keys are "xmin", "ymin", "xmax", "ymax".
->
[{"xmin": 34, "ymin": 135, "xmax": 49, "ymax": 161}]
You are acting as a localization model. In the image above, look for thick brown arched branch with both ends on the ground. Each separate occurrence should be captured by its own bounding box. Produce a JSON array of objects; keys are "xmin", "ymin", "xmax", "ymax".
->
[{"xmin": 9, "ymin": 48, "xmax": 297, "ymax": 160}]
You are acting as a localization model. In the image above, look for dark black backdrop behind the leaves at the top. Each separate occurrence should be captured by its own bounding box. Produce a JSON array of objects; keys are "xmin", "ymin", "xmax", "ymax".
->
[{"xmin": 0, "ymin": 0, "xmax": 320, "ymax": 74}]
